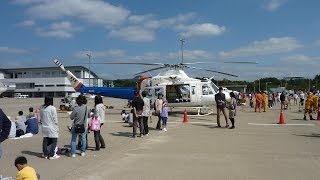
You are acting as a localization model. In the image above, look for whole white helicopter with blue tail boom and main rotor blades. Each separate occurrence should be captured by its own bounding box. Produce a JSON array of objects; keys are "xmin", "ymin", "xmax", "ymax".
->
[{"xmin": 54, "ymin": 60, "xmax": 255, "ymax": 114}]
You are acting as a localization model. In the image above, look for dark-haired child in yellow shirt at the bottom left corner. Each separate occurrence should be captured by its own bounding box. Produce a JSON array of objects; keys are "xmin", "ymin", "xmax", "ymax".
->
[{"xmin": 14, "ymin": 156, "xmax": 38, "ymax": 180}]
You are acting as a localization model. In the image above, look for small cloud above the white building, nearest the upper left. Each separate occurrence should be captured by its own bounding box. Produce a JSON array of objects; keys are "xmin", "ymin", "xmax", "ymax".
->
[{"xmin": 36, "ymin": 21, "xmax": 81, "ymax": 39}]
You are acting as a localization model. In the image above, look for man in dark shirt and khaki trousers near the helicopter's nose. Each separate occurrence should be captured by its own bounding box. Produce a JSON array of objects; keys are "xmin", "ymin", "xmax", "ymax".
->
[{"xmin": 215, "ymin": 87, "xmax": 229, "ymax": 127}]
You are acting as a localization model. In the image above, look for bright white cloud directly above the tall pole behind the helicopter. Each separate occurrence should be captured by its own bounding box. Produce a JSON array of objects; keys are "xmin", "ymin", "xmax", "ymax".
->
[{"xmin": 176, "ymin": 23, "xmax": 226, "ymax": 37}]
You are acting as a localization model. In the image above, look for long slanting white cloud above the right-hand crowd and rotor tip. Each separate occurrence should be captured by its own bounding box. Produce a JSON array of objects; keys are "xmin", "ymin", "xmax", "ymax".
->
[{"xmin": 219, "ymin": 37, "xmax": 303, "ymax": 58}]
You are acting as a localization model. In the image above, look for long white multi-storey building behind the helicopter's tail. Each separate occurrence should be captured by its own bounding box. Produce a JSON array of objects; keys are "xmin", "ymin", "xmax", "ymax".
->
[{"xmin": 0, "ymin": 66, "xmax": 103, "ymax": 97}]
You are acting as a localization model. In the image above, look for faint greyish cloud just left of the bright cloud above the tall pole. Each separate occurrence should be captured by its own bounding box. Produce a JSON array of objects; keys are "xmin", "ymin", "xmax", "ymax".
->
[{"xmin": 109, "ymin": 26, "xmax": 155, "ymax": 42}]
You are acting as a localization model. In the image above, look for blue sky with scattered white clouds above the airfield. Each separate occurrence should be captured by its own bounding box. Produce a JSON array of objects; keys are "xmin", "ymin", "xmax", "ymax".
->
[{"xmin": 0, "ymin": 0, "xmax": 320, "ymax": 81}]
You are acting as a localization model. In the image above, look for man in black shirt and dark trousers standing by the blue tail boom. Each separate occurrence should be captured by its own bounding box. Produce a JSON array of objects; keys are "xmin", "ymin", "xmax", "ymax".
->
[{"xmin": 132, "ymin": 91, "xmax": 144, "ymax": 138}]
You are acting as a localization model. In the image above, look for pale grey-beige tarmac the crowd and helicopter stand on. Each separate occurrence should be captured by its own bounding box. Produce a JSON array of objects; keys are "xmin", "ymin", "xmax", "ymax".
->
[{"xmin": 0, "ymin": 98, "xmax": 320, "ymax": 180}]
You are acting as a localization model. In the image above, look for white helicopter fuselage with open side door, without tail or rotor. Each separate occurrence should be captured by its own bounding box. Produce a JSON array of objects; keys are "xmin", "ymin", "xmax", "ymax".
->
[{"xmin": 140, "ymin": 70, "xmax": 230, "ymax": 107}]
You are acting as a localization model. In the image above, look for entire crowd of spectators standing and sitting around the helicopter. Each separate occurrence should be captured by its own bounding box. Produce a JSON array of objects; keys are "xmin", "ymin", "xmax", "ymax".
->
[{"xmin": 0, "ymin": 87, "xmax": 320, "ymax": 179}]
